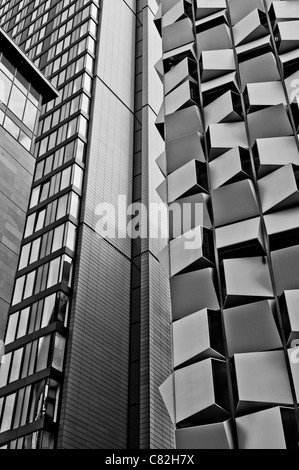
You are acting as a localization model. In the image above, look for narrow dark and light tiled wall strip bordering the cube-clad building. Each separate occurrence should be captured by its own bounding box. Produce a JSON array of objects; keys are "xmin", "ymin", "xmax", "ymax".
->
[{"xmin": 128, "ymin": 0, "xmax": 174, "ymax": 449}]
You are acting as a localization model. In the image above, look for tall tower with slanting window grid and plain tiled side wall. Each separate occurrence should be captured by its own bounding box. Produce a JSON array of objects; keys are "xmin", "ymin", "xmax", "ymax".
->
[{"xmin": 0, "ymin": 0, "xmax": 174, "ymax": 449}]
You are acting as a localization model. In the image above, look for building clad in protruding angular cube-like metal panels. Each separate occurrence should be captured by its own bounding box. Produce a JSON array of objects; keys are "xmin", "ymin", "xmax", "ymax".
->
[{"xmin": 155, "ymin": 0, "xmax": 299, "ymax": 449}]
